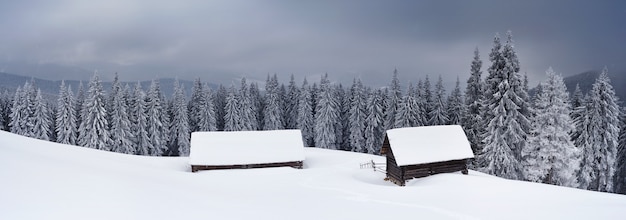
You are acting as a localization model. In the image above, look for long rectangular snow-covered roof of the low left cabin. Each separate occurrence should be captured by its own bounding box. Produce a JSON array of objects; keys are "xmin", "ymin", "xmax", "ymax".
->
[{"xmin": 189, "ymin": 130, "xmax": 304, "ymax": 166}]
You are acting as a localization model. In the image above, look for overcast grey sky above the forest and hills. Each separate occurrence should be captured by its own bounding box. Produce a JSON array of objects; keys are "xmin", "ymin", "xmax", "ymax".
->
[{"xmin": 0, "ymin": 0, "xmax": 626, "ymax": 86}]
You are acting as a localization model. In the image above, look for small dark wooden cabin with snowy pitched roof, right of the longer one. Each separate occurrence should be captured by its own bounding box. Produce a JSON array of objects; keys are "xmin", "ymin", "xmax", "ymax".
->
[{"xmin": 381, "ymin": 125, "xmax": 474, "ymax": 186}]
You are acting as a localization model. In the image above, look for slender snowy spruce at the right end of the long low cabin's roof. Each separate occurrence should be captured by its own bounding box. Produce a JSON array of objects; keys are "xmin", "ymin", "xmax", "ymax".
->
[{"xmin": 296, "ymin": 78, "xmax": 315, "ymax": 147}]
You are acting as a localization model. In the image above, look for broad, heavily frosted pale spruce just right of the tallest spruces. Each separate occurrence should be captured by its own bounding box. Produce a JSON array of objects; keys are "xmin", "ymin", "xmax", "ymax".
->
[{"xmin": 522, "ymin": 68, "xmax": 579, "ymax": 187}]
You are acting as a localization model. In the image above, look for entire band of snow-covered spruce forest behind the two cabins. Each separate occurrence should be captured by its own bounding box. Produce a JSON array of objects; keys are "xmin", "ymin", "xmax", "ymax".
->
[{"xmin": 0, "ymin": 32, "xmax": 626, "ymax": 193}]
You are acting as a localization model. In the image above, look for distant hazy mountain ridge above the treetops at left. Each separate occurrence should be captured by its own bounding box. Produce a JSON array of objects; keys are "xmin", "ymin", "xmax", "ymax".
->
[{"xmin": 0, "ymin": 72, "xmax": 218, "ymax": 98}]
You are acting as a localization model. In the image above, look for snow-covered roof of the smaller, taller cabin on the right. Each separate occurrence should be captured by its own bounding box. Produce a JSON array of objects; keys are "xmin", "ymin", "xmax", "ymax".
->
[{"xmin": 387, "ymin": 125, "xmax": 474, "ymax": 166}]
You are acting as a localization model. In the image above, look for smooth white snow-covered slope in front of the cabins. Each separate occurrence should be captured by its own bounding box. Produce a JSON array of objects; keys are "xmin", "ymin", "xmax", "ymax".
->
[{"xmin": 0, "ymin": 132, "xmax": 626, "ymax": 219}]
